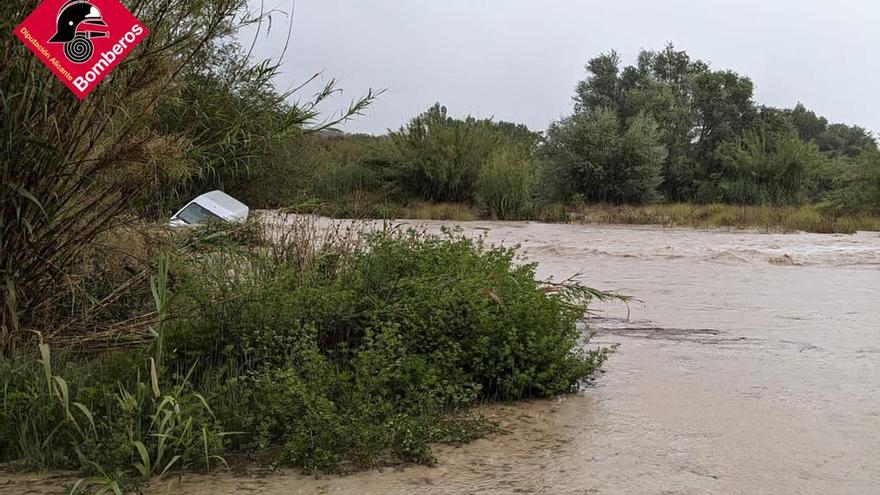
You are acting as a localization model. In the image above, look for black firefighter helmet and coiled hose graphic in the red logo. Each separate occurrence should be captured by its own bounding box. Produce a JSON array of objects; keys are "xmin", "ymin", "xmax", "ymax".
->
[{"xmin": 49, "ymin": 0, "xmax": 108, "ymax": 64}]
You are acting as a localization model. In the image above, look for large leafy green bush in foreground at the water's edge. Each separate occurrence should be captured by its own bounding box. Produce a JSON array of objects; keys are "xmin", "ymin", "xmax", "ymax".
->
[{"xmin": 166, "ymin": 227, "xmax": 607, "ymax": 470}]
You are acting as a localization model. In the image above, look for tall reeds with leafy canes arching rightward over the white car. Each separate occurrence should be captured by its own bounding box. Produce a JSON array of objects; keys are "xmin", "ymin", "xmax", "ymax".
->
[{"xmin": 0, "ymin": 0, "xmax": 376, "ymax": 350}]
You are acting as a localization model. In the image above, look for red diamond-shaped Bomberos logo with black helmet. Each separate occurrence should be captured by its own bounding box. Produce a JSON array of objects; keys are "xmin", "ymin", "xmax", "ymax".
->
[{"xmin": 15, "ymin": 0, "xmax": 149, "ymax": 100}]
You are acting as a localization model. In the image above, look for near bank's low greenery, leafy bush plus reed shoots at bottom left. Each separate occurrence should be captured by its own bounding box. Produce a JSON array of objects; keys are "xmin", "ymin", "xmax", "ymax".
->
[{"xmin": 0, "ymin": 221, "xmax": 611, "ymax": 491}]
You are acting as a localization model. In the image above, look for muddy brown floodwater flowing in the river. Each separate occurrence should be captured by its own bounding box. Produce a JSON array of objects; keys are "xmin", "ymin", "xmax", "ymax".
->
[{"xmin": 6, "ymin": 222, "xmax": 880, "ymax": 495}]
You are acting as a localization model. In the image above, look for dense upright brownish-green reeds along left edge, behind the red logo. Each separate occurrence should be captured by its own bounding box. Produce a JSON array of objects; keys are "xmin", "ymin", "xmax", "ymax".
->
[{"xmin": 0, "ymin": 0, "xmax": 253, "ymax": 347}]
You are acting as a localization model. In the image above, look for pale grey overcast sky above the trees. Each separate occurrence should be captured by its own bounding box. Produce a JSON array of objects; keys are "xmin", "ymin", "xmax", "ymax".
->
[{"xmin": 247, "ymin": 0, "xmax": 880, "ymax": 134}]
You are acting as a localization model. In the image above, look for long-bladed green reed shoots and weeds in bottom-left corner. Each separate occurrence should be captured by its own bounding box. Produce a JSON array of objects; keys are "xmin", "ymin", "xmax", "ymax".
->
[{"xmin": 0, "ymin": 338, "xmax": 225, "ymax": 488}]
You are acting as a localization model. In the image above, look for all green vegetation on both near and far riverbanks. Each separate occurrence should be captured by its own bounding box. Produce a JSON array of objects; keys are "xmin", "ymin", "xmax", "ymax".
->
[{"xmin": 0, "ymin": 0, "xmax": 880, "ymax": 493}]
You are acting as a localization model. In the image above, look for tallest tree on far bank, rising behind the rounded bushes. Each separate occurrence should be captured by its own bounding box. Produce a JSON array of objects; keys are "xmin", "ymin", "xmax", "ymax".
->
[{"xmin": 575, "ymin": 44, "xmax": 756, "ymax": 200}]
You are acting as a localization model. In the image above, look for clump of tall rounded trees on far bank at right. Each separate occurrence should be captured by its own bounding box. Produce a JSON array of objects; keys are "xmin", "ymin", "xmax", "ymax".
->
[{"xmin": 545, "ymin": 44, "xmax": 877, "ymax": 207}]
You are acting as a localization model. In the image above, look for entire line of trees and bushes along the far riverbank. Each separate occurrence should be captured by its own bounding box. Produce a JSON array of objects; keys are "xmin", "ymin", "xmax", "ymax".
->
[{"xmin": 230, "ymin": 45, "xmax": 880, "ymax": 232}]
